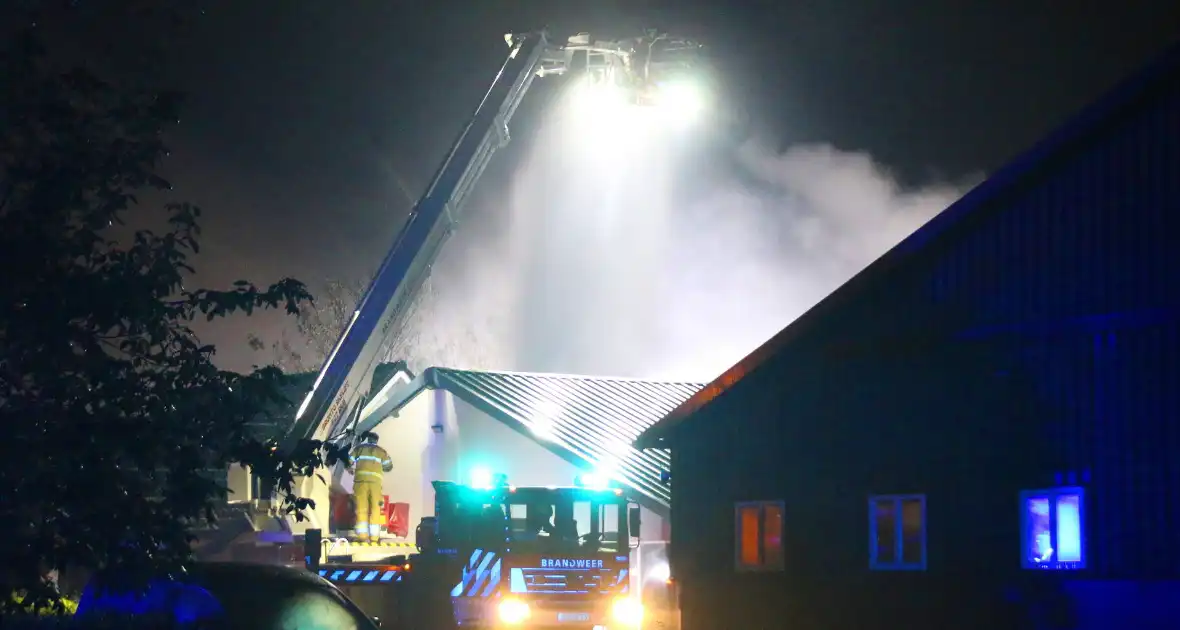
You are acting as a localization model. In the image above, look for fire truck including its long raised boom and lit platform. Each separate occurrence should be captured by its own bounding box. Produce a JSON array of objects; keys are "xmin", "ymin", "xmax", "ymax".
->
[{"xmin": 258, "ymin": 31, "xmax": 701, "ymax": 629}]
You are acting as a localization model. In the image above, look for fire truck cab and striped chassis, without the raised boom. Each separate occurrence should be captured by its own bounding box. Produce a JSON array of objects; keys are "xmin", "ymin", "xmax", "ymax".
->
[{"xmin": 306, "ymin": 481, "xmax": 644, "ymax": 629}]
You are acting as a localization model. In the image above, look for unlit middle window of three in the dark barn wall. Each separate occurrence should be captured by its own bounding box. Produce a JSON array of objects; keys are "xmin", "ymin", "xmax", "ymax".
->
[{"xmin": 868, "ymin": 494, "xmax": 926, "ymax": 571}]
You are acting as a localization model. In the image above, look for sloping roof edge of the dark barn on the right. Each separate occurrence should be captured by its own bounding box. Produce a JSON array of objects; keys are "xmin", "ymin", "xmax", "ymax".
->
[{"xmin": 635, "ymin": 39, "xmax": 1180, "ymax": 448}]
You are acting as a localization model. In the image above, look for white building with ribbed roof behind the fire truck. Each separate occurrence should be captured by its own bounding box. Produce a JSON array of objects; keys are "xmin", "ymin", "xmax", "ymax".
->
[{"xmin": 344, "ymin": 367, "xmax": 701, "ymax": 540}]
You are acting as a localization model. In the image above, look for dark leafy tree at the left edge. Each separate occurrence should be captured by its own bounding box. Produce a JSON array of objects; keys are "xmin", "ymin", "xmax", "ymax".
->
[{"xmin": 0, "ymin": 28, "xmax": 340, "ymax": 613}]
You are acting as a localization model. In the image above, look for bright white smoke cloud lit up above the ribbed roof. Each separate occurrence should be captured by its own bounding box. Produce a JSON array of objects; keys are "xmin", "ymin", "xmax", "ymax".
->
[{"xmin": 401, "ymin": 90, "xmax": 964, "ymax": 381}]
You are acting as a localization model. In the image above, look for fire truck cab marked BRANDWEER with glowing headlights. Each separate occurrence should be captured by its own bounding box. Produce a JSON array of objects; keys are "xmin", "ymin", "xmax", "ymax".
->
[{"xmin": 424, "ymin": 481, "xmax": 643, "ymax": 628}]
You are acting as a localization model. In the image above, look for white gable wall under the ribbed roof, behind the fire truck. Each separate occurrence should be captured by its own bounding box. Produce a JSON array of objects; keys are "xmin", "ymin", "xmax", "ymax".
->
[{"xmin": 358, "ymin": 389, "xmax": 663, "ymax": 549}]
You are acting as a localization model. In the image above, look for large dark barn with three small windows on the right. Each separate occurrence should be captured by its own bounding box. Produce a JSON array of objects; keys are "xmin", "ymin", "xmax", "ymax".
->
[{"xmin": 636, "ymin": 41, "xmax": 1180, "ymax": 630}]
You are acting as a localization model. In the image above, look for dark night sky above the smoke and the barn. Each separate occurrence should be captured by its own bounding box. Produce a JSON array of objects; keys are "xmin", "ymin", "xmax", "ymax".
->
[{"xmin": 11, "ymin": 0, "xmax": 1180, "ymax": 367}]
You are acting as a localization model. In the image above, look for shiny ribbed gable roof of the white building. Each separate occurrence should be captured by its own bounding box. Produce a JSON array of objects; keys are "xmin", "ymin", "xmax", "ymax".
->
[{"xmin": 358, "ymin": 367, "xmax": 702, "ymax": 513}]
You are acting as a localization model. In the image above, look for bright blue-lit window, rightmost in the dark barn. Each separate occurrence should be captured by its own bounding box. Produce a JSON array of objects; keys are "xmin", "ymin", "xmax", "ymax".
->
[{"xmin": 1021, "ymin": 487, "xmax": 1086, "ymax": 571}]
